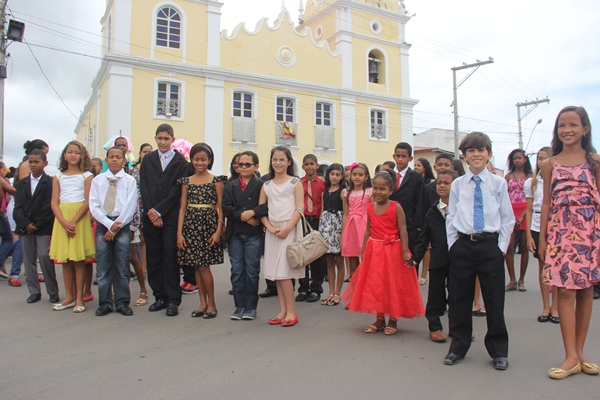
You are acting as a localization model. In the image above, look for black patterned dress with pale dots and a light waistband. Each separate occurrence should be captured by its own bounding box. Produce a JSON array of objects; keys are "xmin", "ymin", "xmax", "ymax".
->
[{"xmin": 177, "ymin": 176, "xmax": 227, "ymax": 267}]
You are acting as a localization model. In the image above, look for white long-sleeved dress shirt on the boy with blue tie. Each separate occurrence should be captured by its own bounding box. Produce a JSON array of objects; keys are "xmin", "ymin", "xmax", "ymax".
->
[{"xmin": 446, "ymin": 168, "xmax": 515, "ymax": 254}]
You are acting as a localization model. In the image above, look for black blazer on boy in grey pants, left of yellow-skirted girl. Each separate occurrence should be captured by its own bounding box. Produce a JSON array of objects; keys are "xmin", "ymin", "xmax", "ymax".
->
[{"xmin": 13, "ymin": 173, "xmax": 54, "ymax": 236}]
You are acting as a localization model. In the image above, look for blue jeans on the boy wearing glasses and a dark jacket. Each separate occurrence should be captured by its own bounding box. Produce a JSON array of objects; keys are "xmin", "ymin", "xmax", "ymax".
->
[{"xmin": 228, "ymin": 234, "xmax": 264, "ymax": 310}]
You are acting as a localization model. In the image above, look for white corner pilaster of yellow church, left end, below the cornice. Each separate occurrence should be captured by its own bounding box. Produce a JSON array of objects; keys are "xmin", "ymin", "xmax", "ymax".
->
[{"xmin": 106, "ymin": 65, "xmax": 133, "ymax": 141}]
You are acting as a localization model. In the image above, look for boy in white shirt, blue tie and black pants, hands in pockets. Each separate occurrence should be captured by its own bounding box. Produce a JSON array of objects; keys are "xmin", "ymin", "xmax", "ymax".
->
[{"xmin": 444, "ymin": 132, "xmax": 515, "ymax": 370}]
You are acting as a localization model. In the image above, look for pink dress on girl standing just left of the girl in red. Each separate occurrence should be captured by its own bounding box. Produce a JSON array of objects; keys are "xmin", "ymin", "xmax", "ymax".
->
[{"xmin": 342, "ymin": 188, "xmax": 373, "ymax": 257}]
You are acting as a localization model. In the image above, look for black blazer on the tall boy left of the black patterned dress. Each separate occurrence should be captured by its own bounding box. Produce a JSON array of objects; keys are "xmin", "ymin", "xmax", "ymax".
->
[{"xmin": 140, "ymin": 150, "xmax": 191, "ymax": 223}]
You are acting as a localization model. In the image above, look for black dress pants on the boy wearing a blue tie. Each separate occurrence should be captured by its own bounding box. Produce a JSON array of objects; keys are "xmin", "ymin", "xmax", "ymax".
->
[{"xmin": 448, "ymin": 235, "xmax": 508, "ymax": 358}]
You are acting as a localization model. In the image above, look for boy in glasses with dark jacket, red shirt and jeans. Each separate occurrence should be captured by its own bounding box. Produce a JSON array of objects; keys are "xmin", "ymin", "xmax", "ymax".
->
[{"xmin": 222, "ymin": 151, "xmax": 268, "ymax": 320}]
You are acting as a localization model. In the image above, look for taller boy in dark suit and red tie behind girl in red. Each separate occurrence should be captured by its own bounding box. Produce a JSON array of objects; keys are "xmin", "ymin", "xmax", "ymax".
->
[{"xmin": 390, "ymin": 142, "xmax": 424, "ymax": 253}]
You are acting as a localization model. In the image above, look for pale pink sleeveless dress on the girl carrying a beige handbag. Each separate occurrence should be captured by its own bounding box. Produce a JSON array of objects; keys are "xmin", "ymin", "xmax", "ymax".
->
[{"xmin": 263, "ymin": 178, "xmax": 305, "ymax": 281}]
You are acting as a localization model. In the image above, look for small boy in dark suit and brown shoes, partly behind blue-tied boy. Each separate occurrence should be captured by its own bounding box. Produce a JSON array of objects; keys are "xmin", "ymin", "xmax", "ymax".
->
[{"xmin": 413, "ymin": 169, "xmax": 458, "ymax": 342}]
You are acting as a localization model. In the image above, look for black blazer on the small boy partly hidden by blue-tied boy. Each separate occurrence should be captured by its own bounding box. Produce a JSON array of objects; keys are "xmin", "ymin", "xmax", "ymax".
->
[{"xmin": 413, "ymin": 200, "xmax": 450, "ymax": 269}]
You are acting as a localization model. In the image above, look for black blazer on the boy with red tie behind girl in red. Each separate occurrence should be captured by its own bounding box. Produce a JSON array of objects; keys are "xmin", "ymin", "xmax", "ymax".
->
[{"xmin": 390, "ymin": 168, "xmax": 424, "ymax": 231}]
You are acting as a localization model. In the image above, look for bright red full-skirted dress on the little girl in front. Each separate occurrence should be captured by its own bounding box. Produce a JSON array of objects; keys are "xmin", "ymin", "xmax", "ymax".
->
[{"xmin": 342, "ymin": 201, "xmax": 425, "ymax": 318}]
